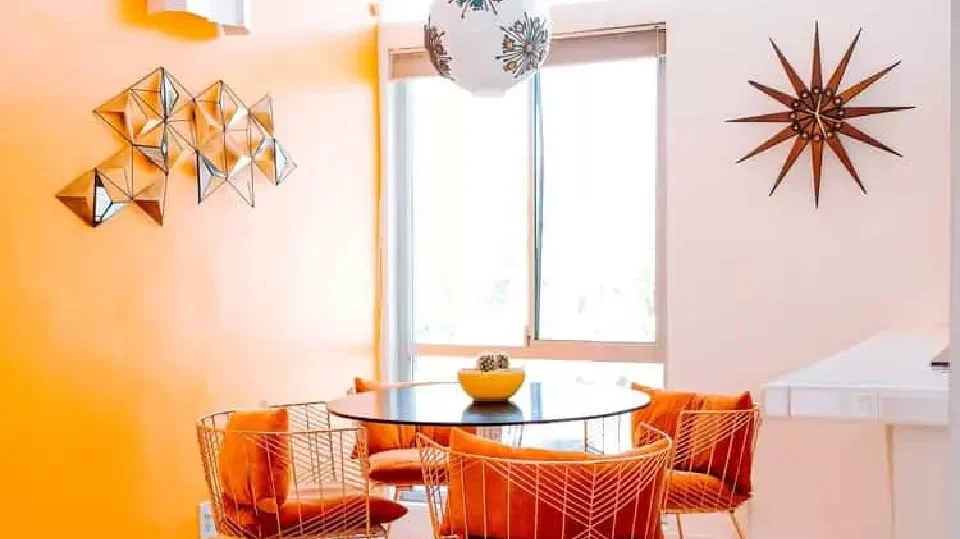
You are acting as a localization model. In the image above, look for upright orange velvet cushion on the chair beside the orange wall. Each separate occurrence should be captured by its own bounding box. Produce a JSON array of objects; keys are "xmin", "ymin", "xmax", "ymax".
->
[{"xmin": 219, "ymin": 408, "xmax": 290, "ymax": 514}]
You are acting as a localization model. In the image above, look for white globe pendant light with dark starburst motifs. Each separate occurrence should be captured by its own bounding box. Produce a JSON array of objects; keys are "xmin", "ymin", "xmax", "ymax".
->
[{"xmin": 423, "ymin": 0, "xmax": 552, "ymax": 96}]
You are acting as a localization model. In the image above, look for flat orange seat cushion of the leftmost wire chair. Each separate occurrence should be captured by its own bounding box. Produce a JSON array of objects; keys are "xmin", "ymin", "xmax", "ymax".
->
[{"xmin": 224, "ymin": 494, "xmax": 407, "ymax": 537}]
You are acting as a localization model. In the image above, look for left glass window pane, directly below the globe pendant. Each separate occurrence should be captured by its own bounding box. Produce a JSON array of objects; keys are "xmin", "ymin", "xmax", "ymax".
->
[{"xmin": 406, "ymin": 77, "xmax": 530, "ymax": 345}]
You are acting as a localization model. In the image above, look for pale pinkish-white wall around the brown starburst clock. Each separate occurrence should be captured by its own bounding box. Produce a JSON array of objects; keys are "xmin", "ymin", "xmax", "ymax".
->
[{"xmin": 384, "ymin": 0, "xmax": 950, "ymax": 539}]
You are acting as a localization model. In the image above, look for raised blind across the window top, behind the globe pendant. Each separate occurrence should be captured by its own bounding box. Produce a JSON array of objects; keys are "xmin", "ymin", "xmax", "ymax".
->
[{"xmin": 390, "ymin": 25, "xmax": 666, "ymax": 80}]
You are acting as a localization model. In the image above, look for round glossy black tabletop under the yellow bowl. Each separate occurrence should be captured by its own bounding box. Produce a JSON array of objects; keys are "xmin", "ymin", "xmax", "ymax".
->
[{"xmin": 327, "ymin": 382, "xmax": 650, "ymax": 427}]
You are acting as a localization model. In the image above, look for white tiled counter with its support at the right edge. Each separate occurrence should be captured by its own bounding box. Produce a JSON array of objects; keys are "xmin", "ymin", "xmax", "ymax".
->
[{"xmin": 763, "ymin": 329, "xmax": 960, "ymax": 539}]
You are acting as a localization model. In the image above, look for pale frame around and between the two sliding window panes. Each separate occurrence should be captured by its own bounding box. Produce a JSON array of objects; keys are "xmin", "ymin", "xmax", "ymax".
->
[{"xmin": 378, "ymin": 16, "xmax": 667, "ymax": 381}]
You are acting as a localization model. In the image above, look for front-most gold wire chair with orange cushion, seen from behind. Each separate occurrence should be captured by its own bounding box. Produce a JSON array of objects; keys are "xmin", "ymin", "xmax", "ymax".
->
[{"xmin": 418, "ymin": 428, "xmax": 673, "ymax": 539}]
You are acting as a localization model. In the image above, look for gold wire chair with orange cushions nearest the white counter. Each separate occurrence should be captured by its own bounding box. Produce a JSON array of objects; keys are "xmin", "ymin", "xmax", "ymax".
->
[{"xmin": 664, "ymin": 406, "xmax": 761, "ymax": 539}]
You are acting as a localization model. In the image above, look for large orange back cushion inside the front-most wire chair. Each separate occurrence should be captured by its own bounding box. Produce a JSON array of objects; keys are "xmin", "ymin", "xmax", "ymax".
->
[{"xmin": 443, "ymin": 429, "xmax": 669, "ymax": 539}]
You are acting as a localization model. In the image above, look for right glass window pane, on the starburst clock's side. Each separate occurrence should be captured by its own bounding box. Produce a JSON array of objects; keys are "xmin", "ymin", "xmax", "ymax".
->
[{"xmin": 538, "ymin": 58, "xmax": 658, "ymax": 342}]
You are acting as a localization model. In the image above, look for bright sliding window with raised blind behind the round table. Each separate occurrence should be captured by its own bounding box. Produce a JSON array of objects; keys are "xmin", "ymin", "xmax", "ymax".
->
[{"xmin": 385, "ymin": 27, "xmax": 664, "ymax": 385}]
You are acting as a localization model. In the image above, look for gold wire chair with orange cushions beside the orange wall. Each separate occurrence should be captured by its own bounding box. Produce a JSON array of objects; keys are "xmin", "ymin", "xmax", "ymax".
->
[{"xmin": 196, "ymin": 401, "xmax": 385, "ymax": 539}]
